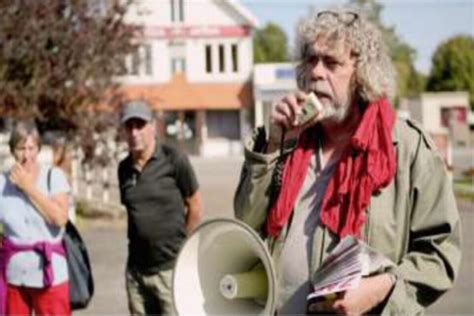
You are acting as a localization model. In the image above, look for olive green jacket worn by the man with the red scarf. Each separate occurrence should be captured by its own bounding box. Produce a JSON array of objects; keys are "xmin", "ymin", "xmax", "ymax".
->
[{"xmin": 234, "ymin": 119, "xmax": 461, "ymax": 315}]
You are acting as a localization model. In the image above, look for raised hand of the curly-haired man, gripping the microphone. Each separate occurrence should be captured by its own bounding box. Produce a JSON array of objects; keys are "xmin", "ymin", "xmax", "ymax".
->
[{"xmin": 267, "ymin": 91, "xmax": 319, "ymax": 153}]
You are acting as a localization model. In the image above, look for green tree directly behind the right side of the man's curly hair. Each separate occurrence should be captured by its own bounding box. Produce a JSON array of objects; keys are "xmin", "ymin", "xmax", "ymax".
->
[{"xmin": 349, "ymin": 0, "xmax": 425, "ymax": 102}]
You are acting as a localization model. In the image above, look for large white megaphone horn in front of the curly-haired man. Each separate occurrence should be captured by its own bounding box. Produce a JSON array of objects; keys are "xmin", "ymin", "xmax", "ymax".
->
[{"xmin": 172, "ymin": 219, "xmax": 277, "ymax": 316}]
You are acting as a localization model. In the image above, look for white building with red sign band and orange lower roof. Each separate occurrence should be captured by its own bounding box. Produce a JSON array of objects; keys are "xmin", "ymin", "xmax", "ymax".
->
[{"xmin": 118, "ymin": 0, "xmax": 257, "ymax": 156}]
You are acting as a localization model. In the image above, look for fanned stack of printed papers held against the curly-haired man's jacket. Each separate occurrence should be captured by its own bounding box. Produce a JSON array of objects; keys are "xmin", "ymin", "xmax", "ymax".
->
[{"xmin": 308, "ymin": 236, "xmax": 393, "ymax": 300}]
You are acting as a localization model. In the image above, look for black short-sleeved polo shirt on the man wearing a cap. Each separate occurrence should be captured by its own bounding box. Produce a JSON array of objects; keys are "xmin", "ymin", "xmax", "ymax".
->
[{"xmin": 118, "ymin": 143, "xmax": 198, "ymax": 273}]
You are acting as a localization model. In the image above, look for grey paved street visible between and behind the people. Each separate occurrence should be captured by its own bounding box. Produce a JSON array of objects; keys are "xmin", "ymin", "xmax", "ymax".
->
[{"xmin": 76, "ymin": 157, "xmax": 474, "ymax": 315}]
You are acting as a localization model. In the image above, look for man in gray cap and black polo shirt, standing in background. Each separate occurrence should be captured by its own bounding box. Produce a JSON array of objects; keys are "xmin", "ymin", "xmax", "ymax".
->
[{"xmin": 118, "ymin": 101, "xmax": 202, "ymax": 315}]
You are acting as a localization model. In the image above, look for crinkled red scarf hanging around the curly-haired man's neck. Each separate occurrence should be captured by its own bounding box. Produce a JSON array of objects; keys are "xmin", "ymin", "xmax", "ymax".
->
[{"xmin": 267, "ymin": 99, "xmax": 396, "ymax": 238}]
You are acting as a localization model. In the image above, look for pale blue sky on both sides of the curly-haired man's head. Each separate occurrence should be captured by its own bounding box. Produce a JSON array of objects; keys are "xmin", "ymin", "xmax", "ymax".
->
[{"xmin": 240, "ymin": 0, "xmax": 474, "ymax": 74}]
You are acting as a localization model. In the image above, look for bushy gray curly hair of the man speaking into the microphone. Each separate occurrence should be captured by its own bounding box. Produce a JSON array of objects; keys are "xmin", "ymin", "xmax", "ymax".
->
[{"xmin": 295, "ymin": 9, "xmax": 396, "ymax": 102}]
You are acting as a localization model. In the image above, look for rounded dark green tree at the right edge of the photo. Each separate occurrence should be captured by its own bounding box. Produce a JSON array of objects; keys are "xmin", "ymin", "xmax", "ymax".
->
[{"xmin": 427, "ymin": 35, "xmax": 474, "ymax": 110}]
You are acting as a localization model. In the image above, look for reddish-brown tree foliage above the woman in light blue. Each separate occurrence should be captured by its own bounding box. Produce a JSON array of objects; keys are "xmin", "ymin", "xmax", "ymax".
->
[{"xmin": 0, "ymin": 0, "xmax": 140, "ymax": 165}]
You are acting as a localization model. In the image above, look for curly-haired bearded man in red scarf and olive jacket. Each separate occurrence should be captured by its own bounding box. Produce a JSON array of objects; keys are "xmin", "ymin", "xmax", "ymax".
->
[{"xmin": 234, "ymin": 6, "xmax": 461, "ymax": 315}]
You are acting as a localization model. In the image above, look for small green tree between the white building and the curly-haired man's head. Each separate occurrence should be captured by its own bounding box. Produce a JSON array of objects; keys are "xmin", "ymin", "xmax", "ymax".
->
[{"xmin": 253, "ymin": 23, "xmax": 288, "ymax": 63}]
